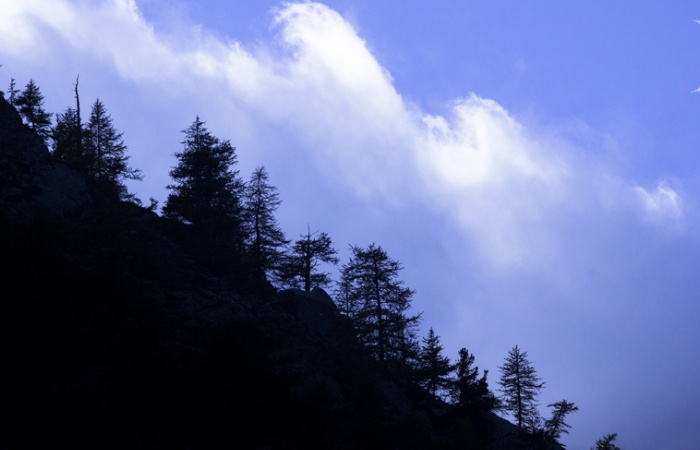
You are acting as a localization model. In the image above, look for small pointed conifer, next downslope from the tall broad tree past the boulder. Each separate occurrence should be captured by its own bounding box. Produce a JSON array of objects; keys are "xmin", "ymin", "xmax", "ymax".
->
[{"xmin": 417, "ymin": 327, "xmax": 454, "ymax": 395}]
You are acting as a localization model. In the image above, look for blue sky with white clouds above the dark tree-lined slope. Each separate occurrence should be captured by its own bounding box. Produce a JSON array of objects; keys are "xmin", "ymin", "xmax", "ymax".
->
[{"xmin": 0, "ymin": 0, "xmax": 700, "ymax": 449}]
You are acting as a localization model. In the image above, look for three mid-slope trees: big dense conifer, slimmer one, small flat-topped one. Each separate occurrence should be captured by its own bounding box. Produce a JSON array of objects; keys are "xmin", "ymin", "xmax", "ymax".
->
[{"xmin": 162, "ymin": 117, "xmax": 338, "ymax": 292}]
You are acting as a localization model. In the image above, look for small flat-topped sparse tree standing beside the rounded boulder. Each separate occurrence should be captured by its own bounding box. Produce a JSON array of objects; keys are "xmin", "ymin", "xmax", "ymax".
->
[{"xmin": 279, "ymin": 230, "xmax": 338, "ymax": 292}]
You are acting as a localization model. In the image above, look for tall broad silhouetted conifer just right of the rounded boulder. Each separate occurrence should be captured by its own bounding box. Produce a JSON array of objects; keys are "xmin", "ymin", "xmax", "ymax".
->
[{"xmin": 341, "ymin": 244, "xmax": 420, "ymax": 363}]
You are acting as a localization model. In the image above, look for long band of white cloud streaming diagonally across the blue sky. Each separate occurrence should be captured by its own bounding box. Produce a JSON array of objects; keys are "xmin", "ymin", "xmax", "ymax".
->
[{"xmin": 0, "ymin": 0, "xmax": 681, "ymax": 266}]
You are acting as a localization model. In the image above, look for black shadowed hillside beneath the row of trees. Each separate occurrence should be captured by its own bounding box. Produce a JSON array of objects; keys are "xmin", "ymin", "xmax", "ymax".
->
[{"xmin": 0, "ymin": 97, "xmax": 560, "ymax": 450}]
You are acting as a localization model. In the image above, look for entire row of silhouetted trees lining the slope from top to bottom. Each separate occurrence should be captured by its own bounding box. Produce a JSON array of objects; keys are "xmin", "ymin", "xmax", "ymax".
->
[{"xmin": 6, "ymin": 74, "xmax": 618, "ymax": 449}]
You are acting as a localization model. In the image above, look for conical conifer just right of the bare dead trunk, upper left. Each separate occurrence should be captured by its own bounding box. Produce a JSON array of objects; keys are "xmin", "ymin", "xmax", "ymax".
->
[{"xmin": 83, "ymin": 99, "xmax": 142, "ymax": 199}]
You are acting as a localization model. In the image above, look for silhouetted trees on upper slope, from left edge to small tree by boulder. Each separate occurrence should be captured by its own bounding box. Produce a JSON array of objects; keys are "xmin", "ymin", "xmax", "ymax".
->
[{"xmin": 6, "ymin": 79, "xmax": 328, "ymax": 291}]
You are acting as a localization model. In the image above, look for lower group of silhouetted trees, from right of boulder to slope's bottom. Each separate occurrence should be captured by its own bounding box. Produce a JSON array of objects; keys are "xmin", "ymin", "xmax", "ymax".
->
[{"xmin": 336, "ymin": 239, "xmax": 616, "ymax": 448}]
